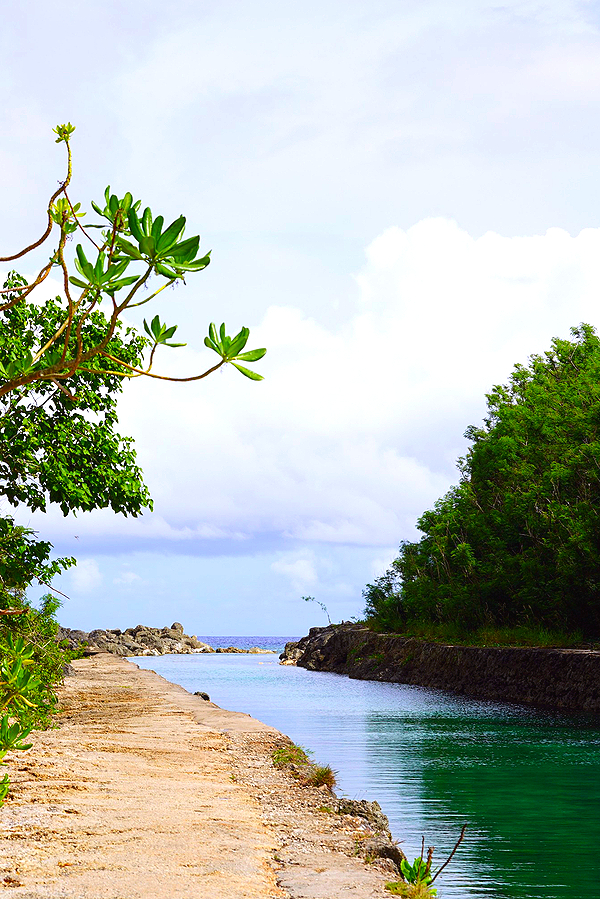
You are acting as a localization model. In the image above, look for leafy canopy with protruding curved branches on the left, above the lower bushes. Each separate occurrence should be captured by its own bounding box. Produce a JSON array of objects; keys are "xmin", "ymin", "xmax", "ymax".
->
[{"xmin": 0, "ymin": 123, "xmax": 266, "ymax": 515}]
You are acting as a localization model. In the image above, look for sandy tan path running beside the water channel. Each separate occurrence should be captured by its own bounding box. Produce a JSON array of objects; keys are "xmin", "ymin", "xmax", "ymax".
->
[{"xmin": 0, "ymin": 653, "xmax": 396, "ymax": 899}]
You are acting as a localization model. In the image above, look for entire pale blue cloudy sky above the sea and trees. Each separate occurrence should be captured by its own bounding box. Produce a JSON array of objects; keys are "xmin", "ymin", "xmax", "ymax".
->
[{"xmin": 0, "ymin": 0, "xmax": 600, "ymax": 636}]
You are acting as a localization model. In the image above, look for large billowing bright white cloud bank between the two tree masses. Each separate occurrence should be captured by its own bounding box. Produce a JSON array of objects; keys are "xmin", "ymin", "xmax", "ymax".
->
[{"xmin": 34, "ymin": 218, "xmax": 600, "ymax": 560}]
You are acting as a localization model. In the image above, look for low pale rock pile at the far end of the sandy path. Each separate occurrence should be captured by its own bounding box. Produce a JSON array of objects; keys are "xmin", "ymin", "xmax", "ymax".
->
[{"xmin": 58, "ymin": 621, "xmax": 273, "ymax": 656}]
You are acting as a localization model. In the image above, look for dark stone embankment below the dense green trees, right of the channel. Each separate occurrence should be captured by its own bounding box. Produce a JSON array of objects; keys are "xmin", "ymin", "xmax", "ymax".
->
[{"xmin": 280, "ymin": 622, "xmax": 600, "ymax": 713}]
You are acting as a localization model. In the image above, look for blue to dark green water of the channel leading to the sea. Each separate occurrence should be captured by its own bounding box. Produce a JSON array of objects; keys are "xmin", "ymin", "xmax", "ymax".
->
[{"xmin": 135, "ymin": 637, "xmax": 600, "ymax": 899}]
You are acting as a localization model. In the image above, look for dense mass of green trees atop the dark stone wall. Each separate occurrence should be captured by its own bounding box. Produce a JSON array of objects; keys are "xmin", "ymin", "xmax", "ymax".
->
[{"xmin": 364, "ymin": 325, "xmax": 600, "ymax": 637}]
